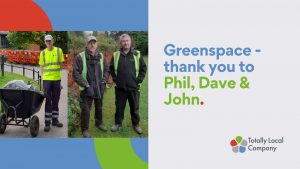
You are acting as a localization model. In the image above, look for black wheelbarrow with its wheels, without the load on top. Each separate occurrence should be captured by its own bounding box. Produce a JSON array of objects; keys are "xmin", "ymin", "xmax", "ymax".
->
[{"xmin": 0, "ymin": 89, "xmax": 44, "ymax": 137}]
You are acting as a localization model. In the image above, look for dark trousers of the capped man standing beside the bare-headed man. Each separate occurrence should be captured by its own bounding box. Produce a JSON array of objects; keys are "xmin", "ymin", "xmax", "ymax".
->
[{"xmin": 80, "ymin": 93, "xmax": 103, "ymax": 131}]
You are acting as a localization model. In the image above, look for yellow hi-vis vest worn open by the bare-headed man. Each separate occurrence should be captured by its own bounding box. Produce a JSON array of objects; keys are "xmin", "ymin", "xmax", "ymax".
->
[{"xmin": 113, "ymin": 50, "xmax": 141, "ymax": 78}]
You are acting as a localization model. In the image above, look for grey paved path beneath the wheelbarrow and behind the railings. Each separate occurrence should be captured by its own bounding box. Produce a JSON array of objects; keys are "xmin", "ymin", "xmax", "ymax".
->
[{"xmin": 0, "ymin": 65, "xmax": 68, "ymax": 138}]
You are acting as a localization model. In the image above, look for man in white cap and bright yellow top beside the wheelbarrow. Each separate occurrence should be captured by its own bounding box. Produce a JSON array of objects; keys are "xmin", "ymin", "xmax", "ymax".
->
[{"xmin": 39, "ymin": 35, "xmax": 64, "ymax": 132}]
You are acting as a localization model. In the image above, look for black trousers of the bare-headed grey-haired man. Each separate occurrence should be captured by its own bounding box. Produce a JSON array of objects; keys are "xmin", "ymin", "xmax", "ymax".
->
[{"xmin": 115, "ymin": 87, "xmax": 140, "ymax": 126}]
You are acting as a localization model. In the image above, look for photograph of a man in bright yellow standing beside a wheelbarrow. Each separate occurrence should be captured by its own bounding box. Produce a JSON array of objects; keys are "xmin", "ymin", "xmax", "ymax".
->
[{"xmin": 0, "ymin": 31, "xmax": 69, "ymax": 138}]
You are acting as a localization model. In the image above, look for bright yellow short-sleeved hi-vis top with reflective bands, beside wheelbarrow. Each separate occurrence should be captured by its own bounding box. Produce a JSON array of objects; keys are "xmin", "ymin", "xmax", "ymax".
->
[{"xmin": 39, "ymin": 47, "xmax": 65, "ymax": 80}]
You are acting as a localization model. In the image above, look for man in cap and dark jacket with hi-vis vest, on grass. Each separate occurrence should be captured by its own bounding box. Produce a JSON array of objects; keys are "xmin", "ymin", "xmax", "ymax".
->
[{"xmin": 73, "ymin": 36, "xmax": 109, "ymax": 138}]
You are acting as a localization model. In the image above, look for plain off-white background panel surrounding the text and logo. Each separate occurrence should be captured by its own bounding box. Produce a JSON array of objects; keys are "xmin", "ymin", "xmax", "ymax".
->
[{"xmin": 149, "ymin": 0, "xmax": 300, "ymax": 169}]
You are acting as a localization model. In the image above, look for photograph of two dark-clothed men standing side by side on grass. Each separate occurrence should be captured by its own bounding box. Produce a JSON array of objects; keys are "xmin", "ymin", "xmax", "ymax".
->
[{"xmin": 68, "ymin": 31, "xmax": 148, "ymax": 138}]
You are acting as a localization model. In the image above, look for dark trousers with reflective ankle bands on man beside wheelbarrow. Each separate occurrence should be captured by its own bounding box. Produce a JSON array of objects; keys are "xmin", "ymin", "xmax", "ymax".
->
[{"xmin": 43, "ymin": 80, "xmax": 61, "ymax": 124}]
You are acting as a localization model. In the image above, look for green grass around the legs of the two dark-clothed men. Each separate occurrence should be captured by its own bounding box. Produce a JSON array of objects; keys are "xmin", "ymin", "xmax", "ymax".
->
[{"xmin": 70, "ymin": 57, "xmax": 148, "ymax": 138}]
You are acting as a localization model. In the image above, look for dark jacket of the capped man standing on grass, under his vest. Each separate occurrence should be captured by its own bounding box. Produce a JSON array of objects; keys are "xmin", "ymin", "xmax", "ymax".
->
[{"xmin": 73, "ymin": 50, "xmax": 109, "ymax": 98}]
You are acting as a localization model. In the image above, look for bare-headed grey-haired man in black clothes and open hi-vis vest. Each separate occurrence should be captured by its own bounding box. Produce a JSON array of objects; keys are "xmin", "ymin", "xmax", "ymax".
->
[{"xmin": 110, "ymin": 34, "xmax": 147, "ymax": 134}]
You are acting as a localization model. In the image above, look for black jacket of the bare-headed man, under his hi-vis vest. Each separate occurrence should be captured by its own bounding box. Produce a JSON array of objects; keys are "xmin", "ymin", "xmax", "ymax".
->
[{"xmin": 109, "ymin": 49, "xmax": 147, "ymax": 90}]
